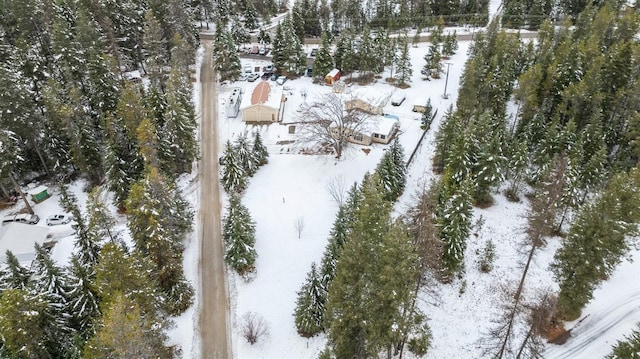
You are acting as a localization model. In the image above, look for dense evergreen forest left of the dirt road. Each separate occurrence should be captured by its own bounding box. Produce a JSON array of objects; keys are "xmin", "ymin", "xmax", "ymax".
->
[{"xmin": 0, "ymin": 0, "xmax": 198, "ymax": 358}]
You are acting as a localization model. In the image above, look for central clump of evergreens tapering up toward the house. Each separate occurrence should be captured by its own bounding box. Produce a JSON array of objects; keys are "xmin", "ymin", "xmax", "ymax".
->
[{"xmin": 294, "ymin": 140, "xmax": 430, "ymax": 358}]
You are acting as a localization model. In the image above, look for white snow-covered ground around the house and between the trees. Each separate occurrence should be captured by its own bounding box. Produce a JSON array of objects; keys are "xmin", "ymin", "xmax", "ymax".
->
[{"xmin": 1, "ymin": 20, "xmax": 640, "ymax": 359}]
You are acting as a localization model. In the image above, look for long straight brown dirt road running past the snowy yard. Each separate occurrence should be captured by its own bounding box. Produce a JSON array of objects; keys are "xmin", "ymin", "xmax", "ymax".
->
[{"xmin": 199, "ymin": 39, "xmax": 232, "ymax": 359}]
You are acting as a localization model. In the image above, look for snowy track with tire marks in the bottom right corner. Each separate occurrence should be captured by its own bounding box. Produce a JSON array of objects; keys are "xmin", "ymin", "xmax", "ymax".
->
[{"xmin": 545, "ymin": 291, "xmax": 640, "ymax": 359}]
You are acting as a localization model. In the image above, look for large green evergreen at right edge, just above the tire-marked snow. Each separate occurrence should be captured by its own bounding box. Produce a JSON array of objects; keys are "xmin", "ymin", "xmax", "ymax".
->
[{"xmin": 552, "ymin": 170, "xmax": 640, "ymax": 320}]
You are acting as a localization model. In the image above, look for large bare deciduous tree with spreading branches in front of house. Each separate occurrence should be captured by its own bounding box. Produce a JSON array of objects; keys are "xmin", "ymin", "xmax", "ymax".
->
[{"xmin": 298, "ymin": 93, "xmax": 372, "ymax": 159}]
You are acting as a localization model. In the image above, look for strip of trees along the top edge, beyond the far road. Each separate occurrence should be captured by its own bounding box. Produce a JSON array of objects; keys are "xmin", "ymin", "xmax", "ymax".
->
[{"xmin": 195, "ymin": 0, "xmax": 489, "ymax": 37}]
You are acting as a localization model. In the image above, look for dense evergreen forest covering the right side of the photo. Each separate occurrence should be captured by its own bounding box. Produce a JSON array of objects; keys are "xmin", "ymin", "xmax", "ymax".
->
[{"xmin": 424, "ymin": 3, "xmax": 640, "ymax": 357}]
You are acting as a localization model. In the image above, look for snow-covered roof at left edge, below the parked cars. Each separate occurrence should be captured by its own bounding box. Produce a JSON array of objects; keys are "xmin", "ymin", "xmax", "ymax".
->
[{"xmin": 0, "ymin": 223, "xmax": 49, "ymax": 266}]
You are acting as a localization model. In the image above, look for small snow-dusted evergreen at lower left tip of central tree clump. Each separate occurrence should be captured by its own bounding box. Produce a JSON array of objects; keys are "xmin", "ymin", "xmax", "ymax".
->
[{"xmin": 294, "ymin": 262, "xmax": 326, "ymax": 338}]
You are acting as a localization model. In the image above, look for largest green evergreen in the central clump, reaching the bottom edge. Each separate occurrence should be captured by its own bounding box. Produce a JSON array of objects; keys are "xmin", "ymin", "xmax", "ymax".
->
[{"xmin": 325, "ymin": 176, "xmax": 428, "ymax": 358}]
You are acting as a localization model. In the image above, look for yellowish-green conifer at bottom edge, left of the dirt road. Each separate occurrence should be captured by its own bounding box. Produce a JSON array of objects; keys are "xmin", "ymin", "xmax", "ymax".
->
[{"xmin": 83, "ymin": 292, "xmax": 175, "ymax": 359}]
